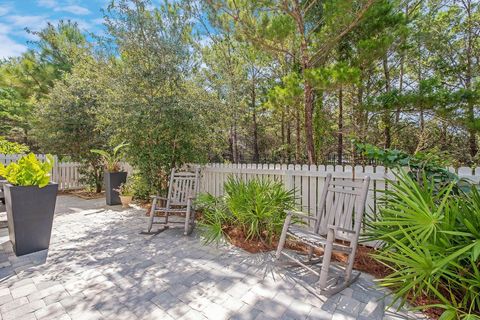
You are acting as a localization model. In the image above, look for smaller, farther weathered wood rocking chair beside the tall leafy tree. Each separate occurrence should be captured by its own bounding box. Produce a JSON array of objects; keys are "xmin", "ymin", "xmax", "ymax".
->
[{"xmin": 147, "ymin": 168, "xmax": 200, "ymax": 235}]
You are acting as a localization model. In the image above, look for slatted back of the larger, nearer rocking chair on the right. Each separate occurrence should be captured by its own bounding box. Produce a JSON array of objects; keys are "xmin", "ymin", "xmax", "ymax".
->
[{"xmin": 315, "ymin": 175, "xmax": 370, "ymax": 241}]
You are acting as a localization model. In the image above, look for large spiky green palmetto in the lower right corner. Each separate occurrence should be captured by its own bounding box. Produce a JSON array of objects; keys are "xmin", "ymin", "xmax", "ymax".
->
[{"xmin": 369, "ymin": 171, "xmax": 480, "ymax": 319}]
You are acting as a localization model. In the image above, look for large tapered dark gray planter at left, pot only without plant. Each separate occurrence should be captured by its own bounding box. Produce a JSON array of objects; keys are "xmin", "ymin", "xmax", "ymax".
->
[{"xmin": 4, "ymin": 183, "xmax": 58, "ymax": 256}]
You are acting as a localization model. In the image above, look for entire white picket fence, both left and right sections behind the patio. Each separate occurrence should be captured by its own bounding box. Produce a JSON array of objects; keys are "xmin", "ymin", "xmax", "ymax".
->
[{"xmin": 0, "ymin": 154, "xmax": 480, "ymax": 205}]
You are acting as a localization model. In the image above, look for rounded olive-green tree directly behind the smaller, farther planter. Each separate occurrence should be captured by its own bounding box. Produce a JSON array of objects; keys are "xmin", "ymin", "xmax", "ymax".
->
[{"xmin": 34, "ymin": 58, "xmax": 110, "ymax": 192}]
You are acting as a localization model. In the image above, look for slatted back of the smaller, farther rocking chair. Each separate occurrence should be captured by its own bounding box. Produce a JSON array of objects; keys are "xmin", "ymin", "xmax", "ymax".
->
[{"xmin": 167, "ymin": 169, "xmax": 200, "ymax": 206}]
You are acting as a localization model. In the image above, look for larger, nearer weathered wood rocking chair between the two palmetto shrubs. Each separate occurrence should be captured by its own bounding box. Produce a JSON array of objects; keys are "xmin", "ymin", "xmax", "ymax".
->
[{"xmin": 276, "ymin": 174, "xmax": 370, "ymax": 295}]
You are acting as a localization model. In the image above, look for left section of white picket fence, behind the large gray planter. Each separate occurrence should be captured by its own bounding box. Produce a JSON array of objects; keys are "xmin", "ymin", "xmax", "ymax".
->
[{"xmin": 0, "ymin": 154, "xmax": 83, "ymax": 190}]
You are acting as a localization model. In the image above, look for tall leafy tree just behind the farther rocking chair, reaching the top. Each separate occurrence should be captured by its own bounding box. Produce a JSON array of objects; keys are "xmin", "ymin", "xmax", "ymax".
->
[{"xmin": 98, "ymin": 0, "xmax": 205, "ymax": 192}]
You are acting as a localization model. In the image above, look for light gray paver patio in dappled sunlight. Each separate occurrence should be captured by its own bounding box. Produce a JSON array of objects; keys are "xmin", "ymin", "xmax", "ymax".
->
[{"xmin": 0, "ymin": 196, "xmax": 426, "ymax": 320}]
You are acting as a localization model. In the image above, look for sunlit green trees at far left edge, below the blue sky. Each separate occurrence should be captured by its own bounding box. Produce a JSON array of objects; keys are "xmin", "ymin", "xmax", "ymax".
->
[{"xmin": 0, "ymin": 21, "xmax": 89, "ymax": 144}]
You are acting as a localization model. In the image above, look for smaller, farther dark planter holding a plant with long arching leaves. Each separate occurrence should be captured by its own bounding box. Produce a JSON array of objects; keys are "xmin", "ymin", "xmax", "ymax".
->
[{"xmin": 90, "ymin": 142, "xmax": 128, "ymax": 206}]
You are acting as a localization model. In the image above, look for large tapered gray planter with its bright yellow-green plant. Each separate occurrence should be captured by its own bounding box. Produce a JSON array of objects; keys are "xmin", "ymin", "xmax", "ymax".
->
[{"xmin": 0, "ymin": 153, "xmax": 58, "ymax": 256}]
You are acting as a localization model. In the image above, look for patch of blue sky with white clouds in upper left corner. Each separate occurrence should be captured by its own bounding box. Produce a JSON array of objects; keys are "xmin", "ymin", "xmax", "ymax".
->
[{"xmin": 0, "ymin": 0, "xmax": 109, "ymax": 59}]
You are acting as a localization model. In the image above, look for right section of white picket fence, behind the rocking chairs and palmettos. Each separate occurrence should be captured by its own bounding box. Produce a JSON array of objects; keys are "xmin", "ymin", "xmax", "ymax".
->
[{"xmin": 200, "ymin": 163, "xmax": 480, "ymax": 218}]
